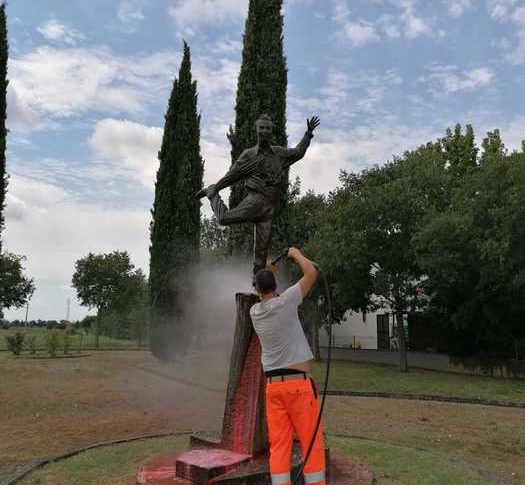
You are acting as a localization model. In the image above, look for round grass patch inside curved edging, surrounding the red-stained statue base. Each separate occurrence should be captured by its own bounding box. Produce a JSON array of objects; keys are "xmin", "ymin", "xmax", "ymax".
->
[{"xmin": 20, "ymin": 436, "xmax": 496, "ymax": 485}]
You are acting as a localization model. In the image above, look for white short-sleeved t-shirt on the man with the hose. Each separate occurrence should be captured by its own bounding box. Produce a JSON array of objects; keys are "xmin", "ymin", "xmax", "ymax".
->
[{"xmin": 250, "ymin": 283, "xmax": 313, "ymax": 371}]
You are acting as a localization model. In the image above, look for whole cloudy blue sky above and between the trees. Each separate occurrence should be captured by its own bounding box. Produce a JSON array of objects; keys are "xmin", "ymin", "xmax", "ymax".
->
[{"xmin": 4, "ymin": 0, "xmax": 525, "ymax": 319}]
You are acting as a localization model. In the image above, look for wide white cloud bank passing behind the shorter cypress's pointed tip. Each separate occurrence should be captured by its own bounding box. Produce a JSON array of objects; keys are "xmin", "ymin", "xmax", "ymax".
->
[{"xmin": 9, "ymin": 43, "xmax": 240, "ymax": 129}]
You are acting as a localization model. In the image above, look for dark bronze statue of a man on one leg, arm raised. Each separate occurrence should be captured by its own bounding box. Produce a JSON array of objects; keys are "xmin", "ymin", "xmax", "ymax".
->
[{"xmin": 197, "ymin": 115, "xmax": 319, "ymax": 274}]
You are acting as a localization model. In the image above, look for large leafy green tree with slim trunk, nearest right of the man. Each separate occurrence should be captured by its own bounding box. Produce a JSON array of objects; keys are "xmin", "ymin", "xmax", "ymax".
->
[{"xmin": 311, "ymin": 143, "xmax": 450, "ymax": 371}]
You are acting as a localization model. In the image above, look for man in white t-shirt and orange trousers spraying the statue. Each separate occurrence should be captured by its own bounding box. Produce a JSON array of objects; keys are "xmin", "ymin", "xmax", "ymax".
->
[{"xmin": 250, "ymin": 248, "xmax": 326, "ymax": 485}]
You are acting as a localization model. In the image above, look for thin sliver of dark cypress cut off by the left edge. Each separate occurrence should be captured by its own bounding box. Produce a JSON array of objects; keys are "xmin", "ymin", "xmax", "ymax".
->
[{"xmin": 0, "ymin": 3, "xmax": 9, "ymax": 253}]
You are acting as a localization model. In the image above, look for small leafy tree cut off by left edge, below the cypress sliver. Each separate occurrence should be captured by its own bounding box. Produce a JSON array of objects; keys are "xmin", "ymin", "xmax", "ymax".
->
[{"xmin": 0, "ymin": 253, "xmax": 35, "ymax": 314}]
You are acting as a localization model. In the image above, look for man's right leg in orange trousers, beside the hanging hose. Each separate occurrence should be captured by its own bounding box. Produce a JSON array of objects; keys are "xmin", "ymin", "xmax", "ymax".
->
[{"xmin": 287, "ymin": 379, "xmax": 326, "ymax": 485}]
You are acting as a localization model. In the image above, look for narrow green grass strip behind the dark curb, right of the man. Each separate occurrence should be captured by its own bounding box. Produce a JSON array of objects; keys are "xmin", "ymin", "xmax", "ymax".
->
[{"xmin": 313, "ymin": 361, "xmax": 525, "ymax": 402}]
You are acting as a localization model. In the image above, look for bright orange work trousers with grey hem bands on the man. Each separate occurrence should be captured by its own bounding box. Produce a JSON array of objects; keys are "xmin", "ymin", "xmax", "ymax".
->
[{"xmin": 266, "ymin": 375, "xmax": 326, "ymax": 485}]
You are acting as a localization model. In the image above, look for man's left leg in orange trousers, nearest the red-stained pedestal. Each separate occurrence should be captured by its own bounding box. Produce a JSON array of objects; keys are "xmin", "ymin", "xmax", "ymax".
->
[{"xmin": 266, "ymin": 382, "xmax": 293, "ymax": 485}]
